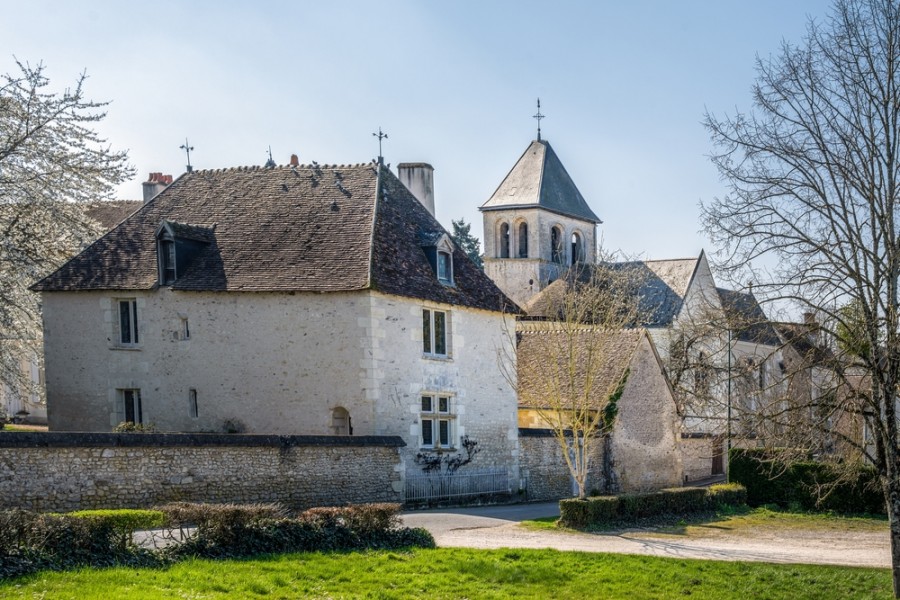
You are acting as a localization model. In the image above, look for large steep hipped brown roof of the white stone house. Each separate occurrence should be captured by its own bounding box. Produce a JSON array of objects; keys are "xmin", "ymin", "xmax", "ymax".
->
[{"xmin": 32, "ymin": 163, "xmax": 518, "ymax": 312}]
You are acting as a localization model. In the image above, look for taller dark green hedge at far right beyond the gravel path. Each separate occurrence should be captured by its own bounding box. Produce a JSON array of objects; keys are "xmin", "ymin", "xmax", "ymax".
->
[{"xmin": 730, "ymin": 448, "xmax": 886, "ymax": 514}]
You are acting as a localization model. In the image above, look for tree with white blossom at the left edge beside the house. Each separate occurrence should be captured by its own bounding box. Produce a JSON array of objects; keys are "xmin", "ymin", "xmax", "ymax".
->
[{"xmin": 0, "ymin": 61, "xmax": 133, "ymax": 408}]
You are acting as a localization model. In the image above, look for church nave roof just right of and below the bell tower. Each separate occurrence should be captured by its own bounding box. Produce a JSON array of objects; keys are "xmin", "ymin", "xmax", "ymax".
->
[{"xmin": 525, "ymin": 254, "xmax": 702, "ymax": 327}]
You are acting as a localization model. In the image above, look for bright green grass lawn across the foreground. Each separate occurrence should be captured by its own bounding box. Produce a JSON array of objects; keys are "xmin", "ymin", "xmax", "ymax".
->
[{"xmin": 0, "ymin": 548, "xmax": 891, "ymax": 600}]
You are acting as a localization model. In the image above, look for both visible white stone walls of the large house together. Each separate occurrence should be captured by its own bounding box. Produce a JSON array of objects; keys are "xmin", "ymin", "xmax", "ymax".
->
[{"xmin": 44, "ymin": 288, "xmax": 518, "ymax": 479}]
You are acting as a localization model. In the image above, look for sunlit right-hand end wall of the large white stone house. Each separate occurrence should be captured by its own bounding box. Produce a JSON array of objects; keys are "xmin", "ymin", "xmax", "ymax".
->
[{"xmin": 366, "ymin": 294, "xmax": 518, "ymax": 481}]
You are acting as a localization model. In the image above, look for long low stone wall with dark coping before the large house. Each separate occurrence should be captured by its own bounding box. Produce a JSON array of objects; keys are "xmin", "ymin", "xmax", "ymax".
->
[{"xmin": 0, "ymin": 432, "xmax": 404, "ymax": 511}]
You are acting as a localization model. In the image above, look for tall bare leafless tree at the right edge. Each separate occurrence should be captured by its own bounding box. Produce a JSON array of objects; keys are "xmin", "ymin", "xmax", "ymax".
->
[{"xmin": 702, "ymin": 0, "xmax": 900, "ymax": 596}]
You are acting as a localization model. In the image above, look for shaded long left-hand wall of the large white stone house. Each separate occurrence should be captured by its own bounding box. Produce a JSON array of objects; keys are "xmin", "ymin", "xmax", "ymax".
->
[{"xmin": 44, "ymin": 288, "xmax": 375, "ymax": 434}]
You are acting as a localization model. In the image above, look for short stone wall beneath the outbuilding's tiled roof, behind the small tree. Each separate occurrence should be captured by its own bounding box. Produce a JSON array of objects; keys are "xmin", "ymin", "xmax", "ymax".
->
[{"xmin": 519, "ymin": 429, "xmax": 606, "ymax": 500}]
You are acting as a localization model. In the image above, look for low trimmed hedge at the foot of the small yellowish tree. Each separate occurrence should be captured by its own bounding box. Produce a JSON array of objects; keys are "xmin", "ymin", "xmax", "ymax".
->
[{"xmin": 559, "ymin": 484, "xmax": 747, "ymax": 529}]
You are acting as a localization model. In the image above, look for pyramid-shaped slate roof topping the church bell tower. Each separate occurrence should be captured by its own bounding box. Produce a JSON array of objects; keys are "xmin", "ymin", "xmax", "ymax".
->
[{"xmin": 479, "ymin": 140, "xmax": 602, "ymax": 223}]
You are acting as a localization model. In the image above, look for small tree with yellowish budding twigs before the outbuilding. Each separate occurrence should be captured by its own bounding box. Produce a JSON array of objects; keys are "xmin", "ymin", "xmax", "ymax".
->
[{"xmin": 500, "ymin": 263, "xmax": 642, "ymax": 498}]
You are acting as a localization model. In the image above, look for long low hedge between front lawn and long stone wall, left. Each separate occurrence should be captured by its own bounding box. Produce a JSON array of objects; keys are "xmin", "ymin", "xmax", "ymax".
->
[{"xmin": 0, "ymin": 503, "xmax": 434, "ymax": 578}]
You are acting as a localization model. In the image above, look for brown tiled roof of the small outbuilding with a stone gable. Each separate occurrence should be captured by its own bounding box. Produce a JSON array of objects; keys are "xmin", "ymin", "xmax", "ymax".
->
[{"xmin": 516, "ymin": 321, "xmax": 646, "ymax": 408}]
